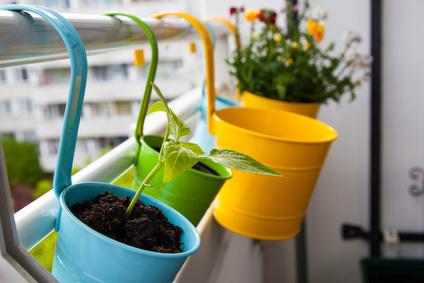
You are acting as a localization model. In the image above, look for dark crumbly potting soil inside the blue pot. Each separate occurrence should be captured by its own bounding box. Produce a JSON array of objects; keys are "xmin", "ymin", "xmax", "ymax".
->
[{"xmin": 71, "ymin": 192, "xmax": 182, "ymax": 253}]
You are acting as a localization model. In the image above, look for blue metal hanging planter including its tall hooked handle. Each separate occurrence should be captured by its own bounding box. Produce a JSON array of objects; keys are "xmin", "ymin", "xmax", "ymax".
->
[{"xmin": 1, "ymin": 5, "xmax": 200, "ymax": 283}]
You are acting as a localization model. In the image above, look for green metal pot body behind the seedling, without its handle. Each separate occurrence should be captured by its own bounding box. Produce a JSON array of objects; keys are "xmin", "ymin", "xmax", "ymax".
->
[{"xmin": 134, "ymin": 136, "xmax": 231, "ymax": 226}]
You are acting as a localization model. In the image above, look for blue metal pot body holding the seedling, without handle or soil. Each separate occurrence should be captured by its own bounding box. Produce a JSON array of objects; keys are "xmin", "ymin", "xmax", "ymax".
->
[{"xmin": 52, "ymin": 183, "xmax": 200, "ymax": 283}]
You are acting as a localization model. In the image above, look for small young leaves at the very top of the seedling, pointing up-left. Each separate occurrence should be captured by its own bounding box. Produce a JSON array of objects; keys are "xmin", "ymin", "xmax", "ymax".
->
[{"xmin": 149, "ymin": 83, "xmax": 191, "ymax": 142}]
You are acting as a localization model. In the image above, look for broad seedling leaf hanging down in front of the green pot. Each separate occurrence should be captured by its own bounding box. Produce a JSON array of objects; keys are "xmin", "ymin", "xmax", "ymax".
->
[{"xmin": 163, "ymin": 142, "xmax": 201, "ymax": 183}]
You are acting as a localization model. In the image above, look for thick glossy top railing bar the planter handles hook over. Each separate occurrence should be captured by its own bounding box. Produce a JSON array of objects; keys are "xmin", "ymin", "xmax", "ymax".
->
[{"xmin": 0, "ymin": 11, "xmax": 228, "ymax": 67}]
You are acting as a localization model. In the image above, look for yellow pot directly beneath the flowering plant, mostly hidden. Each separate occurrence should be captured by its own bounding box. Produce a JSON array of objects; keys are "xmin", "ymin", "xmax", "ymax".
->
[{"xmin": 241, "ymin": 91, "xmax": 320, "ymax": 118}]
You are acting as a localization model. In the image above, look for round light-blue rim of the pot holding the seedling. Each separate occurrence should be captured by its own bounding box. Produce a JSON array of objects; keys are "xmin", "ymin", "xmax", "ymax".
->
[{"xmin": 59, "ymin": 182, "xmax": 200, "ymax": 258}]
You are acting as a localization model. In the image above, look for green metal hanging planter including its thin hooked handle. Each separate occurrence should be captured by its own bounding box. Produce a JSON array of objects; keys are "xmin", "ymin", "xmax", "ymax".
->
[{"xmin": 123, "ymin": 13, "xmax": 231, "ymax": 225}]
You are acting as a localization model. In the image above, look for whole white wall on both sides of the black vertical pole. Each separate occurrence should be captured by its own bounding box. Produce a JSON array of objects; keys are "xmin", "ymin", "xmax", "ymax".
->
[{"xmin": 308, "ymin": 0, "xmax": 424, "ymax": 282}]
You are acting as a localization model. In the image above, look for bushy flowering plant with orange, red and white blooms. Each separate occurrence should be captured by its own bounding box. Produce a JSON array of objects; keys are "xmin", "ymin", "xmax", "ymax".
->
[{"xmin": 228, "ymin": 0, "xmax": 371, "ymax": 103}]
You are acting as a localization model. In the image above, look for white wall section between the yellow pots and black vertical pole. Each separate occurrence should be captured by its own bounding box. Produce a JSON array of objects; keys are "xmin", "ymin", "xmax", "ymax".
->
[{"xmin": 307, "ymin": 0, "xmax": 370, "ymax": 283}]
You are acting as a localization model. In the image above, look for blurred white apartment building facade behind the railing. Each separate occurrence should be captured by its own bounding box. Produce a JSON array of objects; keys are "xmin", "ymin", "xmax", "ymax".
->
[{"xmin": 0, "ymin": 0, "xmax": 199, "ymax": 172}]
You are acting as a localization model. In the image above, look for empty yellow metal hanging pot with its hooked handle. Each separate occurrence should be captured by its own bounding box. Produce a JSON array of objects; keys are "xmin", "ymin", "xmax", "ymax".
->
[{"xmin": 156, "ymin": 12, "xmax": 337, "ymax": 240}]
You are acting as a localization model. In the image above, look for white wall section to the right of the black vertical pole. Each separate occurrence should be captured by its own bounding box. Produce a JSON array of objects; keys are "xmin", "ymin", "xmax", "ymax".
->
[{"xmin": 382, "ymin": 0, "xmax": 424, "ymax": 258}]
